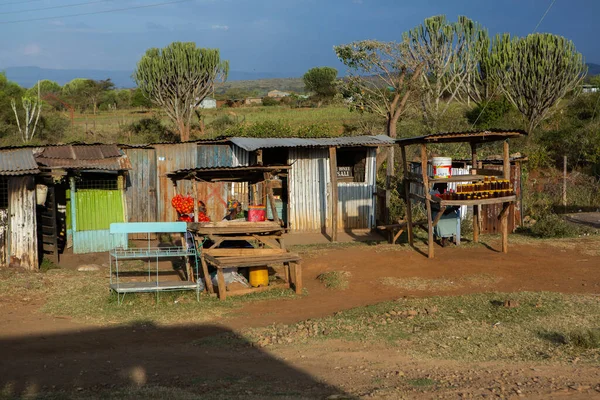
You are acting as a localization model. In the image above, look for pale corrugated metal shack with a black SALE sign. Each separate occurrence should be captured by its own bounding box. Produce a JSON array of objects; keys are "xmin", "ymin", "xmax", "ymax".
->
[{"xmin": 230, "ymin": 136, "xmax": 394, "ymax": 233}]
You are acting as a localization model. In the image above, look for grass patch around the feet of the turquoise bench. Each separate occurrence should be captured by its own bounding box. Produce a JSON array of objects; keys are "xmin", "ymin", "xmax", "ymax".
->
[{"xmin": 0, "ymin": 265, "xmax": 297, "ymax": 324}]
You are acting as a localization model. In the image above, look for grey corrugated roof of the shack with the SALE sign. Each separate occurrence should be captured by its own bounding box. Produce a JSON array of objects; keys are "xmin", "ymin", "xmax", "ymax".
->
[{"xmin": 230, "ymin": 135, "xmax": 395, "ymax": 151}]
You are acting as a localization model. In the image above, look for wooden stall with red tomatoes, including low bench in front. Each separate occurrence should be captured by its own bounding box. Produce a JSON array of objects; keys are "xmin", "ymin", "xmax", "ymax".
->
[{"xmin": 168, "ymin": 166, "xmax": 302, "ymax": 299}]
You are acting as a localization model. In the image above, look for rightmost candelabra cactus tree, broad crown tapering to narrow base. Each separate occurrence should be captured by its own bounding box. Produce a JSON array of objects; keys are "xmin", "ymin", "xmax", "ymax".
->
[{"xmin": 492, "ymin": 33, "xmax": 587, "ymax": 139}]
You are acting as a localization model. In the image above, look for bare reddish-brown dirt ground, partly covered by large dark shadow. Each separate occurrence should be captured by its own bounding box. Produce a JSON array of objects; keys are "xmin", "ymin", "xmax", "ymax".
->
[{"xmin": 0, "ymin": 239, "xmax": 600, "ymax": 398}]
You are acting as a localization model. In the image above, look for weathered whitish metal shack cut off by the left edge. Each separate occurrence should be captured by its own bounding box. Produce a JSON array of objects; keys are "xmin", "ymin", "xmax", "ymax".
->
[{"xmin": 0, "ymin": 148, "xmax": 40, "ymax": 270}]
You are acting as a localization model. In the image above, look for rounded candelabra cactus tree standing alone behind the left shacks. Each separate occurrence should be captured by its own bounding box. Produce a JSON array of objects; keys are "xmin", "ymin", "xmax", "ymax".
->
[{"xmin": 133, "ymin": 42, "xmax": 229, "ymax": 141}]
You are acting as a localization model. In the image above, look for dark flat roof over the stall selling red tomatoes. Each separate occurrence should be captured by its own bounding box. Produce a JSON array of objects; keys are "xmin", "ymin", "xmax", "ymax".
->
[{"xmin": 167, "ymin": 165, "xmax": 291, "ymax": 182}]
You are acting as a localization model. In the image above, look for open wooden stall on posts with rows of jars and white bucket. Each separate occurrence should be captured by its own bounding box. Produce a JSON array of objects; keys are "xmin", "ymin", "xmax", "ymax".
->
[{"xmin": 397, "ymin": 130, "xmax": 526, "ymax": 258}]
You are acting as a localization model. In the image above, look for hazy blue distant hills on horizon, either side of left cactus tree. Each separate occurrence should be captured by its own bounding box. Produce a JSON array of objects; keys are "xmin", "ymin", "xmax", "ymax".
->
[{"xmin": 0, "ymin": 67, "xmax": 298, "ymax": 88}]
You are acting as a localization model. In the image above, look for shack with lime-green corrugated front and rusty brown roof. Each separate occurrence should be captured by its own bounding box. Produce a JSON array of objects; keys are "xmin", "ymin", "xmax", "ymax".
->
[{"xmin": 35, "ymin": 144, "xmax": 131, "ymax": 254}]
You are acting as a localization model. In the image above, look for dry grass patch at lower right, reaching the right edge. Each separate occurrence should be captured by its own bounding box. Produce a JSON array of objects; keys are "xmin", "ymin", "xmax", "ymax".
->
[{"xmin": 246, "ymin": 292, "xmax": 600, "ymax": 363}]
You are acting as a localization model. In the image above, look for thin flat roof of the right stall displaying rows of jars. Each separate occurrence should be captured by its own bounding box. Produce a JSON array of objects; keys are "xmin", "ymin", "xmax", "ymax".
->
[{"xmin": 396, "ymin": 129, "xmax": 527, "ymax": 146}]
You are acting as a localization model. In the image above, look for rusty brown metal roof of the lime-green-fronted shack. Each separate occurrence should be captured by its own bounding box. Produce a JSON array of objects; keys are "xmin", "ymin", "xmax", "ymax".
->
[{"xmin": 35, "ymin": 144, "xmax": 131, "ymax": 171}]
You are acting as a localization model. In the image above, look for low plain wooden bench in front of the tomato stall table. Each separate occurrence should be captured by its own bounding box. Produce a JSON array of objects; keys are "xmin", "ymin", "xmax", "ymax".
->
[{"xmin": 200, "ymin": 248, "xmax": 302, "ymax": 300}]
